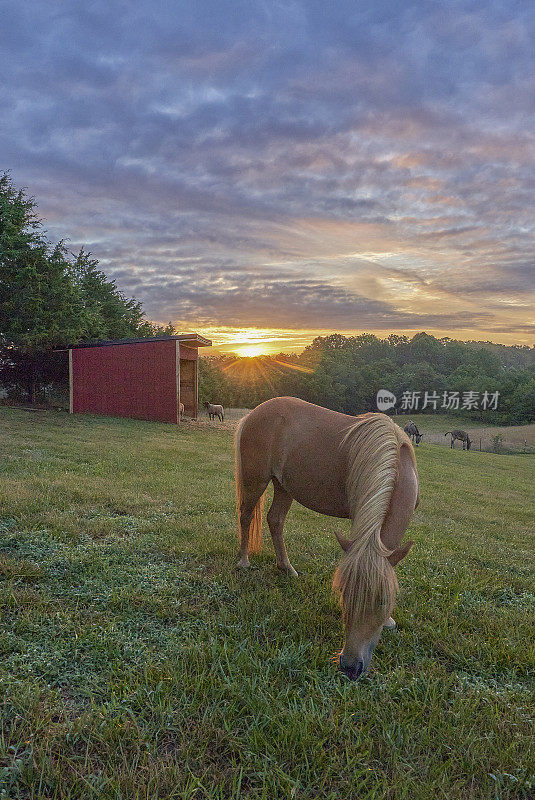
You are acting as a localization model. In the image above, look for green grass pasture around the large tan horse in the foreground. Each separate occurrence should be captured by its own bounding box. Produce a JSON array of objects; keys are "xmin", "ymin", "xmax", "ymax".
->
[{"xmin": 0, "ymin": 408, "xmax": 535, "ymax": 800}]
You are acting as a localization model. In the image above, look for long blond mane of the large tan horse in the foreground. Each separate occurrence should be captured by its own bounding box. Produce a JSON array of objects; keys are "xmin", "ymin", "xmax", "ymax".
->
[{"xmin": 333, "ymin": 414, "xmax": 416, "ymax": 624}]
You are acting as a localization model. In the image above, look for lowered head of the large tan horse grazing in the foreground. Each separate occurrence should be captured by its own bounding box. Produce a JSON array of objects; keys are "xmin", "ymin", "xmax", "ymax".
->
[{"xmin": 335, "ymin": 533, "xmax": 414, "ymax": 680}]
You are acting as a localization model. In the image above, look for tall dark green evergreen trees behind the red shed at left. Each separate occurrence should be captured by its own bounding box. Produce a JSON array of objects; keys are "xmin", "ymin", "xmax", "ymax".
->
[{"xmin": 0, "ymin": 174, "xmax": 163, "ymax": 403}]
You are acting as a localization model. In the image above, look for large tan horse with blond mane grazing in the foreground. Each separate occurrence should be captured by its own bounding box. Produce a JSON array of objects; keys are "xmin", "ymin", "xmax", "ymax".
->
[{"xmin": 236, "ymin": 397, "xmax": 418, "ymax": 680}]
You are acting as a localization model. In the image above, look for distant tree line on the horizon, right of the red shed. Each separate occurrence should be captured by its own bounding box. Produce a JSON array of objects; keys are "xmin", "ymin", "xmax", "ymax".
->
[{"xmin": 201, "ymin": 332, "xmax": 535, "ymax": 424}]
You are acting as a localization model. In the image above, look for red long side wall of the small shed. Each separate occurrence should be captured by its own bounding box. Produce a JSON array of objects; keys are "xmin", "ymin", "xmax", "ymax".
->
[{"xmin": 72, "ymin": 341, "xmax": 178, "ymax": 423}]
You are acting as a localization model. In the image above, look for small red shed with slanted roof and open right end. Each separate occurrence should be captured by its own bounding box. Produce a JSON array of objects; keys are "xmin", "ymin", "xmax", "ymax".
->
[{"xmin": 69, "ymin": 333, "xmax": 212, "ymax": 424}]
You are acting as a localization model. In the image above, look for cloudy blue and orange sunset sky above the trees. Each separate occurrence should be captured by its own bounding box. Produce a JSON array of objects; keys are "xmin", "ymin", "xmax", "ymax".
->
[{"xmin": 0, "ymin": 0, "xmax": 535, "ymax": 355}]
